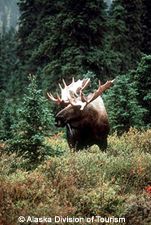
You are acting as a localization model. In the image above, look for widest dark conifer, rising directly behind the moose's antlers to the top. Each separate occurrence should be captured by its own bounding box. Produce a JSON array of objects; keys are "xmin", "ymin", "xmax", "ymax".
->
[{"xmin": 19, "ymin": 0, "xmax": 106, "ymax": 87}]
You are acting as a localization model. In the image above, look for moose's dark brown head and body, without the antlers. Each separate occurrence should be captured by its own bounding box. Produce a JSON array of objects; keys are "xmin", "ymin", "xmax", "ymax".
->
[{"xmin": 56, "ymin": 97, "xmax": 109, "ymax": 150}]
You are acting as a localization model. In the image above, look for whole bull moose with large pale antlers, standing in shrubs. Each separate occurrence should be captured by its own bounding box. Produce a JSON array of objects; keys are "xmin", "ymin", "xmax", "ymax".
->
[{"xmin": 47, "ymin": 78, "xmax": 114, "ymax": 150}]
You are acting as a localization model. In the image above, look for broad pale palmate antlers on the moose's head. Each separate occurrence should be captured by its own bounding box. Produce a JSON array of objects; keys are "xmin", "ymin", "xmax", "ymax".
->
[{"xmin": 47, "ymin": 78, "xmax": 114, "ymax": 110}]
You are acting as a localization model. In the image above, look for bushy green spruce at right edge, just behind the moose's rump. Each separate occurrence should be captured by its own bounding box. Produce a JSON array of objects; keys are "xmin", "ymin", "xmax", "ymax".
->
[{"xmin": 105, "ymin": 55, "xmax": 151, "ymax": 133}]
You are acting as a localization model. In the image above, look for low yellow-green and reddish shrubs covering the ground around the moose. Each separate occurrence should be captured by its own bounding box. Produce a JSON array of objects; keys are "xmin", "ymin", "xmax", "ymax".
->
[{"xmin": 0, "ymin": 129, "xmax": 151, "ymax": 225}]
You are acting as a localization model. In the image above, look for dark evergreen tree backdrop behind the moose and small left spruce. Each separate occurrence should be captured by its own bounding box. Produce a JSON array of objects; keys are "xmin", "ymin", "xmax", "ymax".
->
[{"xmin": 0, "ymin": 0, "xmax": 151, "ymax": 148}]
